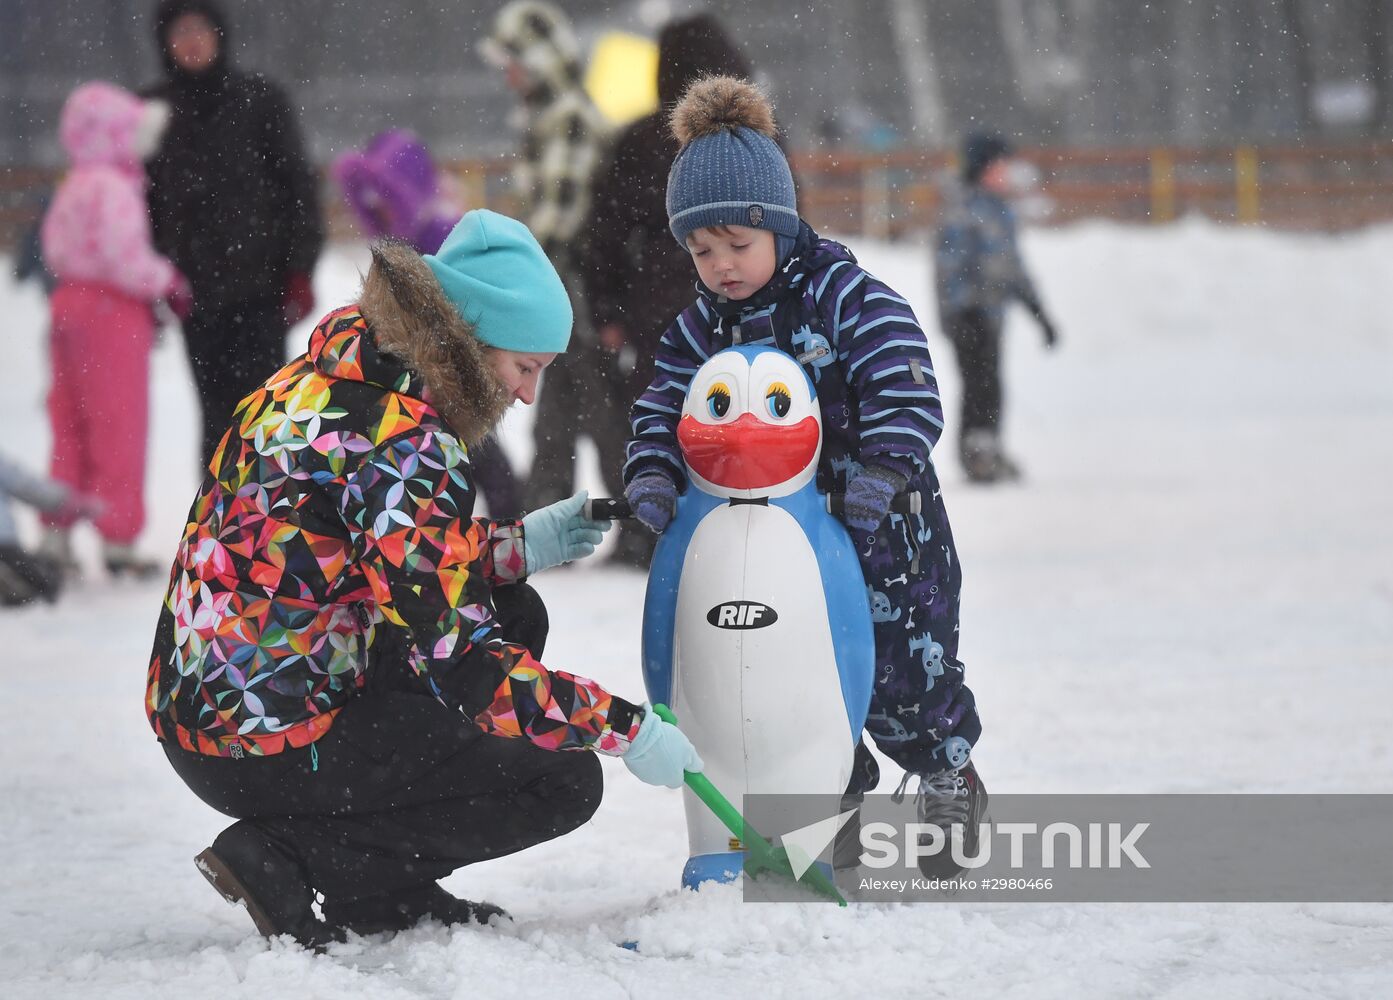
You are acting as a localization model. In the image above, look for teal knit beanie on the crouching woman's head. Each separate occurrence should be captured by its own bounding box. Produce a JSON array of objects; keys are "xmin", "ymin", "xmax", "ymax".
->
[{"xmin": 422, "ymin": 209, "xmax": 573, "ymax": 354}]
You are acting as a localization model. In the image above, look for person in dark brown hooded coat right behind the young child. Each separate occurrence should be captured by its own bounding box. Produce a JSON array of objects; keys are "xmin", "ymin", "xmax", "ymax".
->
[{"xmin": 581, "ymin": 14, "xmax": 749, "ymax": 567}]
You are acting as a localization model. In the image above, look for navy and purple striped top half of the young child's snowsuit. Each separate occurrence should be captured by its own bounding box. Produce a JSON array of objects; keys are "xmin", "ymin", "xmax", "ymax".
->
[{"xmin": 624, "ymin": 223, "xmax": 943, "ymax": 498}]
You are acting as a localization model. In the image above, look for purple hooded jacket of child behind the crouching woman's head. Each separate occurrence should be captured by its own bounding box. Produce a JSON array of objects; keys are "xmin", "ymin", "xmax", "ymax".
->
[{"xmin": 333, "ymin": 128, "xmax": 462, "ymax": 253}]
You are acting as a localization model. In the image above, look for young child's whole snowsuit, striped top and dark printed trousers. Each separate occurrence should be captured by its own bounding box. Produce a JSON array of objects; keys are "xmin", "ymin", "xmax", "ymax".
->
[{"xmin": 624, "ymin": 224, "xmax": 982, "ymax": 787}]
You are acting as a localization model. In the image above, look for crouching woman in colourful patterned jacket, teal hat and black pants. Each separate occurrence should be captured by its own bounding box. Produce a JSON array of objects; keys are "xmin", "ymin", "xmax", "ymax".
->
[{"xmin": 146, "ymin": 210, "xmax": 701, "ymax": 944}]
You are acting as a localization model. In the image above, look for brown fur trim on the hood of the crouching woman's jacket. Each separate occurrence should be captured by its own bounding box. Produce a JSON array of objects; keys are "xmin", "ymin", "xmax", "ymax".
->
[{"xmin": 358, "ymin": 240, "xmax": 513, "ymax": 446}]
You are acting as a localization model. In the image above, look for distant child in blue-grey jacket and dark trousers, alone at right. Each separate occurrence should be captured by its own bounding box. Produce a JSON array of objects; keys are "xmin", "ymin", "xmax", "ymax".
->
[{"xmin": 935, "ymin": 132, "xmax": 1059, "ymax": 483}]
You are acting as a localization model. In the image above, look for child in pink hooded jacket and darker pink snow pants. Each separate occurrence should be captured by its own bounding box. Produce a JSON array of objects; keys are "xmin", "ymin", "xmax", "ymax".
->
[{"xmin": 40, "ymin": 84, "xmax": 191, "ymax": 572}]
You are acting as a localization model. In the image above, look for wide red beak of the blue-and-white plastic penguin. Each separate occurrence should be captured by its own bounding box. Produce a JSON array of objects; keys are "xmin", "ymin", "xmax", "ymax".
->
[{"xmin": 677, "ymin": 414, "xmax": 822, "ymax": 490}]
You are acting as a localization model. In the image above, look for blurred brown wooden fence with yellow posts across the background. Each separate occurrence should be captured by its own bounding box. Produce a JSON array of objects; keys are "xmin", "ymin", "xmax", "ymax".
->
[{"xmin": 0, "ymin": 142, "xmax": 1393, "ymax": 248}]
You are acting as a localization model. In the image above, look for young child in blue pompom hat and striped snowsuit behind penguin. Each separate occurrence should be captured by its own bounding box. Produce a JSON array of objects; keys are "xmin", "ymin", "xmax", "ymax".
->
[{"xmin": 624, "ymin": 77, "xmax": 986, "ymax": 852}]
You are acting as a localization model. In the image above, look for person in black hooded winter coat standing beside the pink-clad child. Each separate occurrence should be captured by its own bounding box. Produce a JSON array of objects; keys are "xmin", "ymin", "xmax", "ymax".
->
[{"xmin": 146, "ymin": 0, "xmax": 323, "ymax": 464}]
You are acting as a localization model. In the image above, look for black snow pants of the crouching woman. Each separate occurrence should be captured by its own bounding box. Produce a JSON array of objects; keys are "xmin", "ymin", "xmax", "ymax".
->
[{"xmin": 164, "ymin": 584, "xmax": 603, "ymax": 905}]
